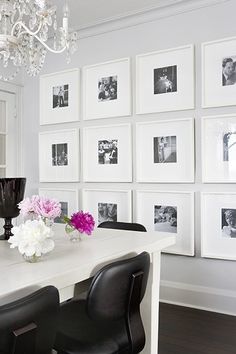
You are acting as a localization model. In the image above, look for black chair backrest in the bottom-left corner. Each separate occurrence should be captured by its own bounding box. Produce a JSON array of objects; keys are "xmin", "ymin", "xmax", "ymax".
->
[{"xmin": 0, "ymin": 286, "xmax": 59, "ymax": 354}]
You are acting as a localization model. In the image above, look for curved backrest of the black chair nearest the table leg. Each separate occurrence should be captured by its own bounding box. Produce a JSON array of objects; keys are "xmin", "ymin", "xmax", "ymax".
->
[{"xmin": 87, "ymin": 252, "xmax": 150, "ymax": 353}]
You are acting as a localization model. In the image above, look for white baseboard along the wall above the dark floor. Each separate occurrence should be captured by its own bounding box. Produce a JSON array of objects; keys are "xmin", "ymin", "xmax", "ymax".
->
[{"xmin": 160, "ymin": 280, "xmax": 236, "ymax": 316}]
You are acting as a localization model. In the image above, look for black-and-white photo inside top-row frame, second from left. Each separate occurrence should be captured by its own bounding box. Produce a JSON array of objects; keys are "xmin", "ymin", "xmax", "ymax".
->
[{"xmin": 98, "ymin": 75, "xmax": 117, "ymax": 102}]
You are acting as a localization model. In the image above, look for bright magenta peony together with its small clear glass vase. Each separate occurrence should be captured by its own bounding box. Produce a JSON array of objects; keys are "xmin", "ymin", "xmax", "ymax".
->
[{"xmin": 64, "ymin": 210, "xmax": 95, "ymax": 241}]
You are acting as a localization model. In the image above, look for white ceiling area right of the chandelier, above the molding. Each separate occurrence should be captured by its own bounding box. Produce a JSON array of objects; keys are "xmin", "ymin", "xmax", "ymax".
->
[{"xmin": 54, "ymin": 0, "xmax": 186, "ymax": 30}]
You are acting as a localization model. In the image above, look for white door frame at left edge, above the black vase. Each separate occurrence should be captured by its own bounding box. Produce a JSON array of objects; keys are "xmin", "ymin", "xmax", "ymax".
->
[{"xmin": 0, "ymin": 81, "xmax": 24, "ymax": 176}]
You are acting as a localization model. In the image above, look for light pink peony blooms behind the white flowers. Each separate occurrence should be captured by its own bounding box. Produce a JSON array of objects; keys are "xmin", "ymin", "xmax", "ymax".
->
[{"xmin": 18, "ymin": 195, "xmax": 61, "ymax": 226}]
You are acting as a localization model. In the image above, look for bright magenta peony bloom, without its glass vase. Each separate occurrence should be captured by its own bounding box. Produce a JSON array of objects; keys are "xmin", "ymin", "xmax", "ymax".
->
[{"xmin": 69, "ymin": 211, "xmax": 95, "ymax": 235}]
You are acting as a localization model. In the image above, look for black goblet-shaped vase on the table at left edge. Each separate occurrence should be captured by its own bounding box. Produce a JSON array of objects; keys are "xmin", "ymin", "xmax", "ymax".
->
[{"xmin": 0, "ymin": 178, "xmax": 26, "ymax": 240}]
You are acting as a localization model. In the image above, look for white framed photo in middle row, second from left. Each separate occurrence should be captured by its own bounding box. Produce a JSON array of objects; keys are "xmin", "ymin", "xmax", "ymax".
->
[{"xmin": 83, "ymin": 124, "xmax": 132, "ymax": 182}]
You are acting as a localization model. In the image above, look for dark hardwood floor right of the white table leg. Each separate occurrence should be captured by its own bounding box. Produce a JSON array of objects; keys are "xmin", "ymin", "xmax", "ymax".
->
[{"xmin": 158, "ymin": 303, "xmax": 236, "ymax": 354}]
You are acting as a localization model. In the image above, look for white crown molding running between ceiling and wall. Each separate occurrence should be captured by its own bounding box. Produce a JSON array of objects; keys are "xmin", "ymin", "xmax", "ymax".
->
[{"xmin": 76, "ymin": 0, "xmax": 230, "ymax": 39}]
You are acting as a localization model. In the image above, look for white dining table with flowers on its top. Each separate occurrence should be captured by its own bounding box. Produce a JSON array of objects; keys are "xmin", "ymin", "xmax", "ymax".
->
[{"xmin": 0, "ymin": 226, "xmax": 175, "ymax": 354}]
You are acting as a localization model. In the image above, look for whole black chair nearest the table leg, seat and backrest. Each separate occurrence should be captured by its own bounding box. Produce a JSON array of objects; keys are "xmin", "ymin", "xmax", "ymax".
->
[{"xmin": 54, "ymin": 252, "xmax": 150, "ymax": 354}]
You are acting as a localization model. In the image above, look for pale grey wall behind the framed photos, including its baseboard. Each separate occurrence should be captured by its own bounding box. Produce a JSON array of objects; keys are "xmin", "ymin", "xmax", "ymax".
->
[{"xmin": 23, "ymin": 0, "xmax": 236, "ymax": 314}]
